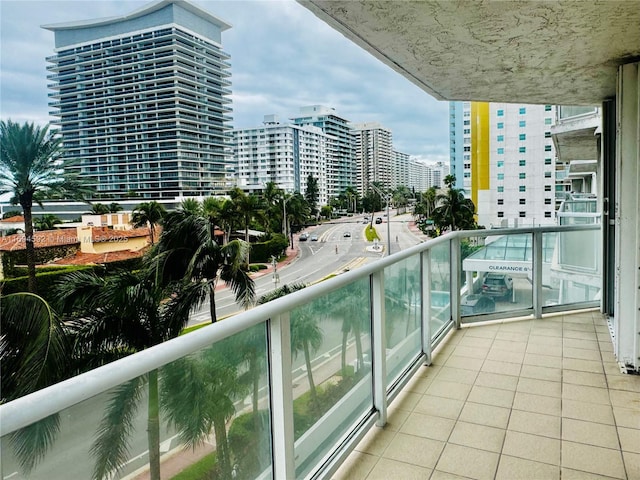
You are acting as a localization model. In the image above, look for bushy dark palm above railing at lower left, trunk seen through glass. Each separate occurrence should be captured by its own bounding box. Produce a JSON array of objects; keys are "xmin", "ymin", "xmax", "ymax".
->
[{"xmin": 57, "ymin": 264, "xmax": 201, "ymax": 480}]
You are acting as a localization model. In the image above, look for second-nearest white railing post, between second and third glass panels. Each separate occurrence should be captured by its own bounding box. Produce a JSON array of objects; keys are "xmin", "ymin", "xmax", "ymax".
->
[{"xmin": 371, "ymin": 269, "xmax": 387, "ymax": 427}]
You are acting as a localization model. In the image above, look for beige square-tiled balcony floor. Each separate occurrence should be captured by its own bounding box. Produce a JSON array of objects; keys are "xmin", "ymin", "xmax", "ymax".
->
[{"xmin": 333, "ymin": 312, "xmax": 640, "ymax": 480}]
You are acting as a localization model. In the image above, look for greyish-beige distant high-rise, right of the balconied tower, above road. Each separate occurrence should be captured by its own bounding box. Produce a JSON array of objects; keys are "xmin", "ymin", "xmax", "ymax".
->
[{"xmin": 351, "ymin": 122, "xmax": 395, "ymax": 195}]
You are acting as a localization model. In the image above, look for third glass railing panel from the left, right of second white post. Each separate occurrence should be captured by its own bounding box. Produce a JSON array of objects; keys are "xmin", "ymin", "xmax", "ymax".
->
[{"xmin": 384, "ymin": 255, "xmax": 421, "ymax": 384}]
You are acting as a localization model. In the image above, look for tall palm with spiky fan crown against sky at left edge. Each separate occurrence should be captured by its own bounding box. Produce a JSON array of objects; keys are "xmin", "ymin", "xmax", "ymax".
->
[{"xmin": 0, "ymin": 120, "xmax": 89, "ymax": 293}]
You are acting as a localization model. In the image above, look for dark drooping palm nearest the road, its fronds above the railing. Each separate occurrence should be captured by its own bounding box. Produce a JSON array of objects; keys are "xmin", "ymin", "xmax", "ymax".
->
[{"xmin": 155, "ymin": 209, "xmax": 255, "ymax": 323}]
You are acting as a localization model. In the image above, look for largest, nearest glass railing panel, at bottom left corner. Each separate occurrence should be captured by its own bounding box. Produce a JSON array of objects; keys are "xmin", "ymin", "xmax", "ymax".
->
[{"xmin": 2, "ymin": 324, "xmax": 272, "ymax": 479}]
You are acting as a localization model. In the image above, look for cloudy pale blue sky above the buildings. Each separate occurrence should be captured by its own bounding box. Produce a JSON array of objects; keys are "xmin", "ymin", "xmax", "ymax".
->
[{"xmin": 0, "ymin": 0, "xmax": 449, "ymax": 162}]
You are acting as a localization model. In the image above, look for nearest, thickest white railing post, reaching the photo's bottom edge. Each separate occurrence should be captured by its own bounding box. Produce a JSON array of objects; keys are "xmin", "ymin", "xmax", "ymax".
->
[{"xmin": 269, "ymin": 312, "xmax": 296, "ymax": 478}]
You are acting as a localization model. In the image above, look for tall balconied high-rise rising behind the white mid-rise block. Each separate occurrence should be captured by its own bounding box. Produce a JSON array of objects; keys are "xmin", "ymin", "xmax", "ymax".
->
[{"xmin": 291, "ymin": 105, "xmax": 356, "ymax": 198}]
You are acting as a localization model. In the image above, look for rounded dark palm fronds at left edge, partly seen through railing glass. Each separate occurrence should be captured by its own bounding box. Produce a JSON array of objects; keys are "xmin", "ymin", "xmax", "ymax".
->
[{"xmin": 0, "ymin": 292, "xmax": 71, "ymax": 476}]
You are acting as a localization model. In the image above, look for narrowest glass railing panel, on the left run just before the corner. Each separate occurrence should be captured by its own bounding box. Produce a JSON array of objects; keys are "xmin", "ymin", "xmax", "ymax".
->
[{"xmin": 429, "ymin": 243, "xmax": 451, "ymax": 340}]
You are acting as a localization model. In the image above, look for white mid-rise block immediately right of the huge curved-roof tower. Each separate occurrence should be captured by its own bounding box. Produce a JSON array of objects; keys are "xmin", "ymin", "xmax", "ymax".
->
[{"xmin": 233, "ymin": 115, "xmax": 328, "ymax": 205}]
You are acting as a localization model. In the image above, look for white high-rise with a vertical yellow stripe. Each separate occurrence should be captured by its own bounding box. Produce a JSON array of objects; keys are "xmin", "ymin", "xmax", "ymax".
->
[{"xmin": 450, "ymin": 102, "xmax": 555, "ymax": 227}]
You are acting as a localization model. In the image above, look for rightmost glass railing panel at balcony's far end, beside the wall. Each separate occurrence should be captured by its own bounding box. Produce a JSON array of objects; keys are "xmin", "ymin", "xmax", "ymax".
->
[{"xmin": 542, "ymin": 230, "xmax": 602, "ymax": 306}]
